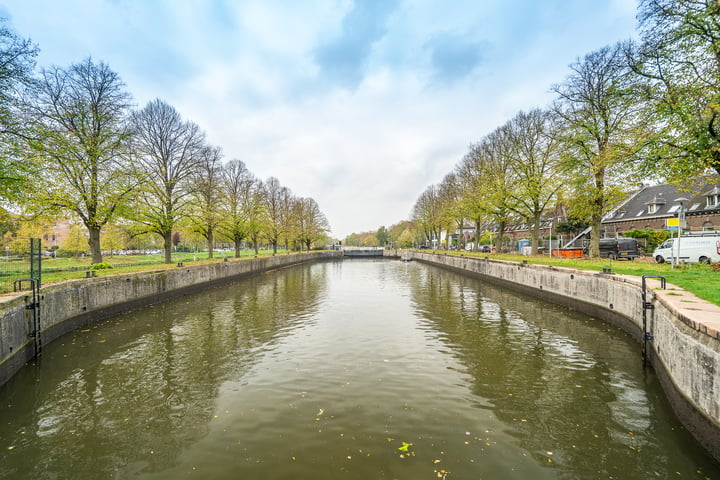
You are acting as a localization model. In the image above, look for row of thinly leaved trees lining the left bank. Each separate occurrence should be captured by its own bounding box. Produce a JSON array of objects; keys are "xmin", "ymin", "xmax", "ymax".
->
[{"xmin": 0, "ymin": 23, "xmax": 329, "ymax": 263}]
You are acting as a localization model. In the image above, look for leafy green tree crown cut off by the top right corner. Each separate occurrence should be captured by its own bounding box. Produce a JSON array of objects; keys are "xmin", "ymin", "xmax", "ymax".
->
[{"xmin": 629, "ymin": 0, "xmax": 720, "ymax": 177}]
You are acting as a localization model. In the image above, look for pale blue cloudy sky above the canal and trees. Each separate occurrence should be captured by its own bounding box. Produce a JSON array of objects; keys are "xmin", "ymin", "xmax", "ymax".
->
[{"xmin": 0, "ymin": 0, "xmax": 637, "ymax": 239}]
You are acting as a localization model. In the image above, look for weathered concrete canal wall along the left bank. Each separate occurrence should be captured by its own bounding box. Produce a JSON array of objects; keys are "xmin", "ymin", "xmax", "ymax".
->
[{"xmin": 0, "ymin": 252, "xmax": 340, "ymax": 385}]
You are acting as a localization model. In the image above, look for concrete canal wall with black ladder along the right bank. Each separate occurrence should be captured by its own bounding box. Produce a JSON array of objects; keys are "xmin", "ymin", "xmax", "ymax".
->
[{"xmin": 386, "ymin": 251, "xmax": 720, "ymax": 461}]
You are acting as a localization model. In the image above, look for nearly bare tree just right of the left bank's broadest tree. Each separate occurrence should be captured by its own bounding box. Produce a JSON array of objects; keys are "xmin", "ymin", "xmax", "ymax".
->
[{"xmin": 132, "ymin": 99, "xmax": 205, "ymax": 263}]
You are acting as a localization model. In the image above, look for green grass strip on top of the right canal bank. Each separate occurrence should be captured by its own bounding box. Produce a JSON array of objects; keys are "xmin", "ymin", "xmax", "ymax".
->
[{"xmin": 420, "ymin": 250, "xmax": 720, "ymax": 305}]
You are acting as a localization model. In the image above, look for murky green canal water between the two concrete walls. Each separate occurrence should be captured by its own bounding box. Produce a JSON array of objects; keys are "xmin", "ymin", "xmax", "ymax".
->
[{"xmin": 0, "ymin": 260, "xmax": 720, "ymax": 480}]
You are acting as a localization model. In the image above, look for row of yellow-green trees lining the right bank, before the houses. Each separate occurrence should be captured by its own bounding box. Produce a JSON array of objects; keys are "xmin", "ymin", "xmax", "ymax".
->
[{"xmin": 412, "ymin": 0, "xmax": 720, "ymax": 256}]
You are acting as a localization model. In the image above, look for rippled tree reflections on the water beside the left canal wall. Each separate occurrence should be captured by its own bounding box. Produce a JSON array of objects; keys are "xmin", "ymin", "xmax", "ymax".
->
[{"xmin": 0, "ymin": 263, "xmax": 328, "ymax": 479}]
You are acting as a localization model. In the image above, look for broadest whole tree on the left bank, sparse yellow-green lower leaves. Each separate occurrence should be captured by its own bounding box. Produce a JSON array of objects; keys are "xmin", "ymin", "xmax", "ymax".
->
[{"xmin": 29, "ymin": 58, "xmax": 137, "ymax": 263}]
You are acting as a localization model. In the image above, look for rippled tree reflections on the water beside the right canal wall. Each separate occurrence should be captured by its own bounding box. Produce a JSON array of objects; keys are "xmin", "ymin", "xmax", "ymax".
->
[{"xmin": 407, "ymin": 266, "xmax": 707, "ymax": 478}]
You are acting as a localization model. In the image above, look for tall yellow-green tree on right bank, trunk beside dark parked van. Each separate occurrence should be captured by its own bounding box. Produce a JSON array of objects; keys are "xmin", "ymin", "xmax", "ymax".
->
[{"xmin": 553, "ymin": 44, "xmax": 648, "ymax": 257}]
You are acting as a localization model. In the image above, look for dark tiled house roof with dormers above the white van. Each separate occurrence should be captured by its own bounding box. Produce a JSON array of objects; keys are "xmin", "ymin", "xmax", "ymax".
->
[{"xmin": 603, "ymin": 176, "xmax": 720, "ymax": 223}]
